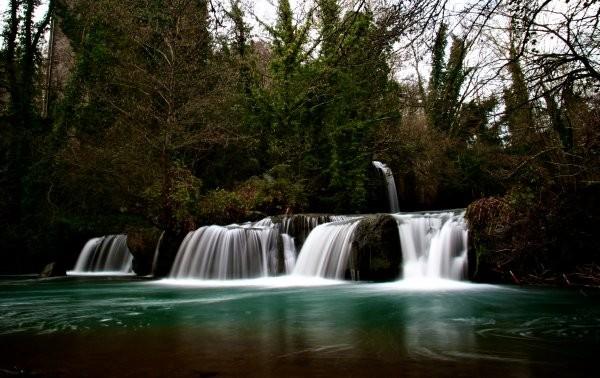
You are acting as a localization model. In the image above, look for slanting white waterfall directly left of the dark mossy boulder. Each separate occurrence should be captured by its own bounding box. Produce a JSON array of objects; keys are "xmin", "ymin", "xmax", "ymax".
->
[{"xmin": 292, "ymin": 219, "xmax": 359, "ymax": 279}]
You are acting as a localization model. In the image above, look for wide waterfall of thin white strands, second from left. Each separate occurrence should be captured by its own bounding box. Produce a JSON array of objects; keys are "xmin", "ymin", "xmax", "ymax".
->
[{"xmin": 169, "ymin": 219, "xmax": 278, "ymax": 280}]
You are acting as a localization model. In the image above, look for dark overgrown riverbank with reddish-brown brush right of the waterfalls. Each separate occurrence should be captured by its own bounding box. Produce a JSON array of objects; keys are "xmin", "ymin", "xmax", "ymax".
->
[{"xmin": 465, "ymin": 187, "xmax": 600, "ymax": 287}]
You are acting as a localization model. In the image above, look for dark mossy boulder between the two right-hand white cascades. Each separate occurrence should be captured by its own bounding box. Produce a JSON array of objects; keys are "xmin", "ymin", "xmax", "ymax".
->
[{"xmin": 349, "ymin": 214, "xmax": 402, "ymax": 282}]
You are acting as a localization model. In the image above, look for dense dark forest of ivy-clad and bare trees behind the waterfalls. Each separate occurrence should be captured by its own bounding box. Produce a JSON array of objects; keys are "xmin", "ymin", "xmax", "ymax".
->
[{"xmin": 0, "ymin": 0, "xmax": 600, "ymax": 285}]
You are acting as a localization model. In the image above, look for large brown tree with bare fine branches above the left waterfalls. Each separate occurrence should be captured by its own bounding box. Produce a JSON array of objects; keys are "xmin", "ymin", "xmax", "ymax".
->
[{"xmin": 52, "ymin": 0, "xmax": 241, "ymax": 232}]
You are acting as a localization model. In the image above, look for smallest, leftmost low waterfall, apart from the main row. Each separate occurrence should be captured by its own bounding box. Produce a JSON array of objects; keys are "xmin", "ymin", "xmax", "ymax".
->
[{"xmin": 72, "ymin": 235, "xmax": 133, "ymax": 274}]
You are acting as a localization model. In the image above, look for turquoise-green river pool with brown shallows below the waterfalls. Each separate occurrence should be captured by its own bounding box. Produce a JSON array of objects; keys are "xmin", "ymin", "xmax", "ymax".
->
[{"xmin": 0, "ymin": 277, "xmax": 600, "ymax": 377}]
